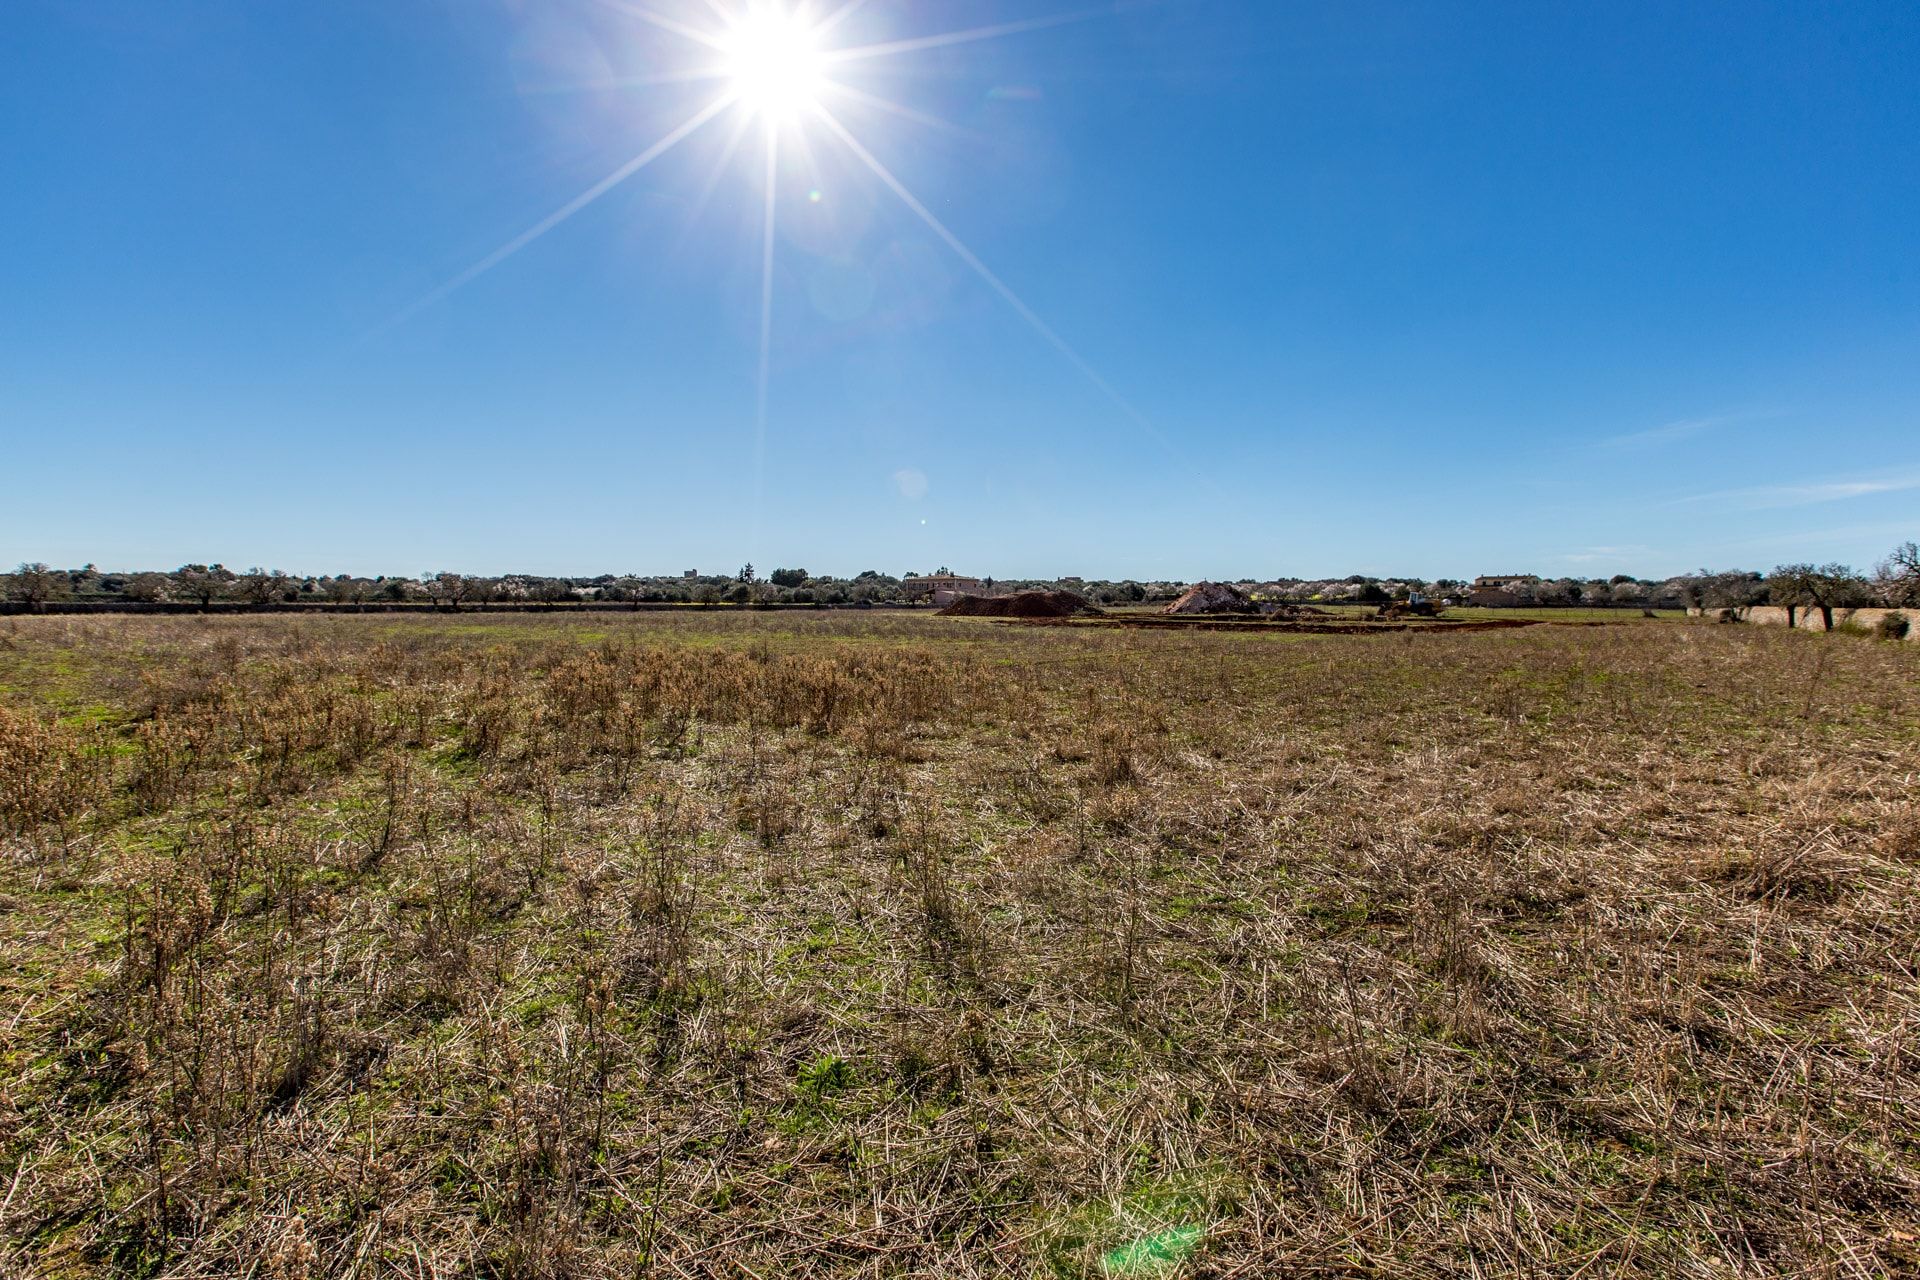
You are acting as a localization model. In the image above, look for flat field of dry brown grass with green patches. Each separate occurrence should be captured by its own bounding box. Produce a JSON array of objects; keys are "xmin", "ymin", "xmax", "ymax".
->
[{"xmin": 0, "ymin": 614, "xmax": 1920, "ymax": 1280}]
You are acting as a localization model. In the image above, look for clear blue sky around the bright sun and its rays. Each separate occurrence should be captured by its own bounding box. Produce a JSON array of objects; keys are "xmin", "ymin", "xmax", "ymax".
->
[{"xmin": 0, "ymin": 0, "xmax": 1920, "ymax": 580}]
